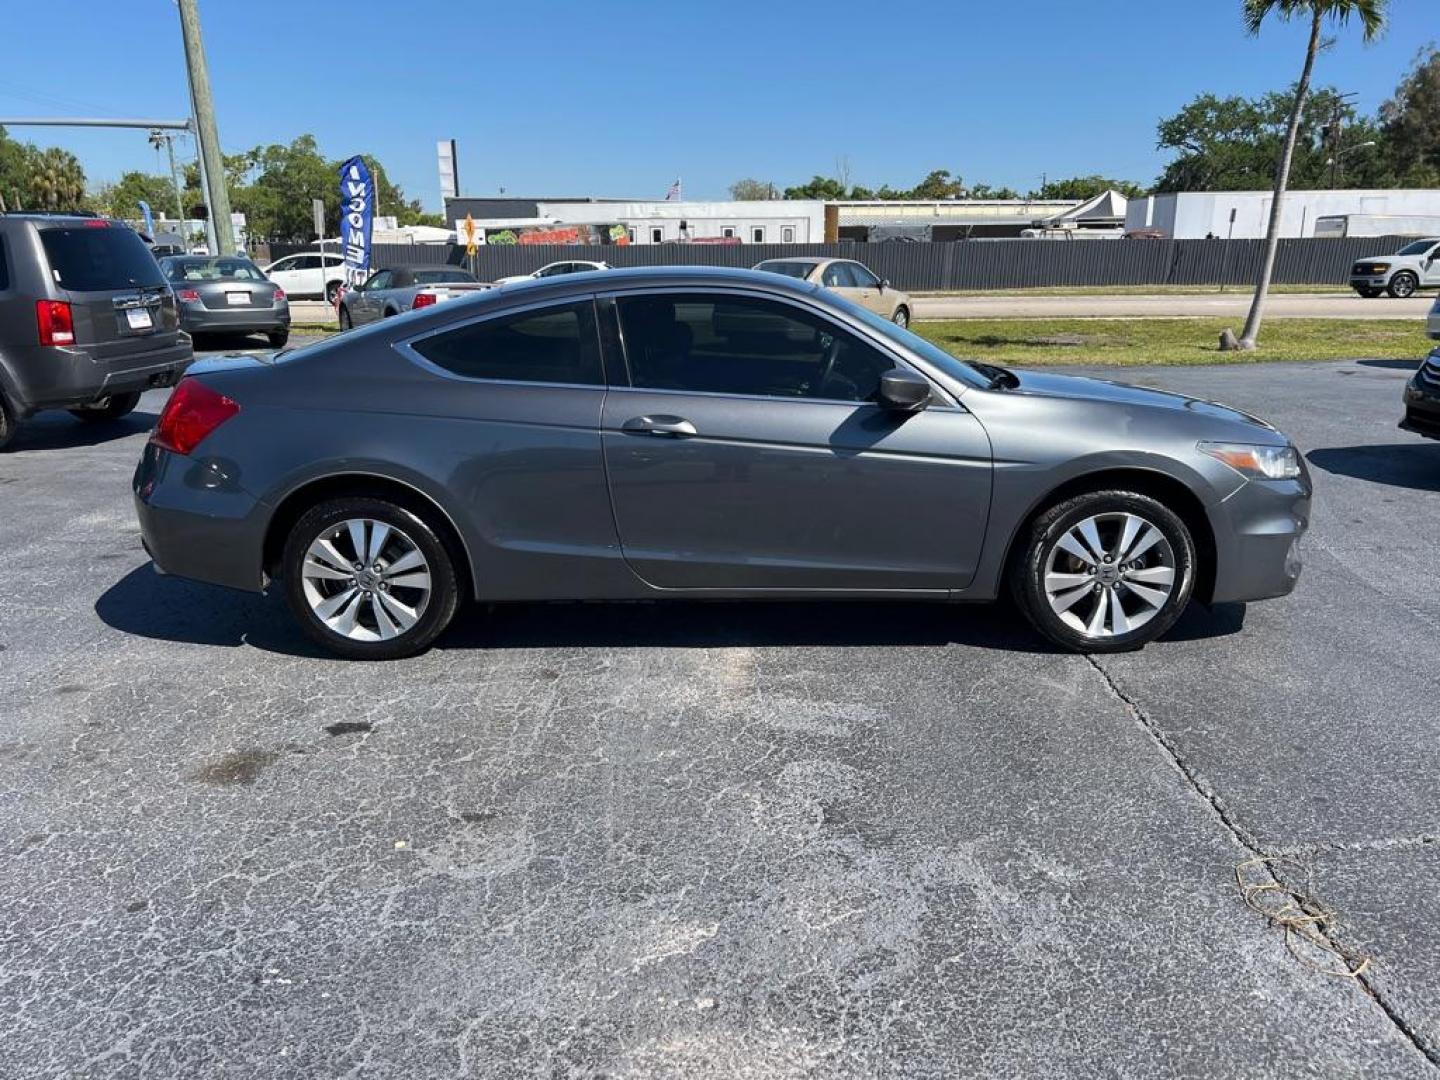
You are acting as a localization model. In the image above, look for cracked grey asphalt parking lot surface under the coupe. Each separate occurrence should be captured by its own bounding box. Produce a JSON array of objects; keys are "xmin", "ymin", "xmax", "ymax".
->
[{"xmin": 0, "ymin": 351, "xmax": 1440, "ymax": 1077}]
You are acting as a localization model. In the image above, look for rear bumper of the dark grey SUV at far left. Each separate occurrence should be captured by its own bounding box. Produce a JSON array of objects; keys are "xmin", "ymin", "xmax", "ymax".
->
[{"xmin": 14, "ymin": 334, "xmax": 194, "ymax": 415}]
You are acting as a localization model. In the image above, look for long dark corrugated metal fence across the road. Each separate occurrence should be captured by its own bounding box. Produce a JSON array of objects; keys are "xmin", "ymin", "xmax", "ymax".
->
[{"xmin": 271, "ymin": 236, "xmax": 1404, "ymax": 291}]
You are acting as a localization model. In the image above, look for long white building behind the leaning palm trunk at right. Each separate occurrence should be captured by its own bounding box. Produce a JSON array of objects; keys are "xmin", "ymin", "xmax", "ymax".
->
[{"xmin": 1125, "ymin": 189, "xmax": 1440, "ymax": 240}]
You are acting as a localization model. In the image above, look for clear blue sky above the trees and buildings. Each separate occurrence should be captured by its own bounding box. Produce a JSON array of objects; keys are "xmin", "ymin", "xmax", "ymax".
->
[{"xmin": 0, "ymin": 0, "xmax": 1440, "ymax": 209}]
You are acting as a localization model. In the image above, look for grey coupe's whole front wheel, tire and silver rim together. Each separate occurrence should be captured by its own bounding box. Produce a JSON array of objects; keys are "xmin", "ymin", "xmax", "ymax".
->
[{"xmin": 1011, "ymin": 491, "xmax": 1195, "ymax": 652}]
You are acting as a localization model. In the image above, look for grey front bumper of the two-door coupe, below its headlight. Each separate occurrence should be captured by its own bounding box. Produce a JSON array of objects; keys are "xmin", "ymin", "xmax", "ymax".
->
[{"xmin": 1210, "ymin": 471, "xmax": 1310, "ymax": 603}]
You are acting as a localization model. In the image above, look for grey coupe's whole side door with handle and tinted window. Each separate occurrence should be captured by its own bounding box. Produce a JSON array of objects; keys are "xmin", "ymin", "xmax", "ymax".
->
[{"xmin": 602, "ymin": 289, "xmax": 991, "ymax": 593}]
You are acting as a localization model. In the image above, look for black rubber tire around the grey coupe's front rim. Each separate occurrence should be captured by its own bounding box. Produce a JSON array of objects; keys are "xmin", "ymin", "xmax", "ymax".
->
[{"xmin": 1009, "ymin": 491, "xmax": 1197, "ymax": 652}]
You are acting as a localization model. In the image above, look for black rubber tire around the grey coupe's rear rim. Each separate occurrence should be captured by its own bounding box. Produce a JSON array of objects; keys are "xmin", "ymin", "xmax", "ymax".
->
[{"xmin": 282, "ymin": 497, "xmax": 459, "ymax": 660}]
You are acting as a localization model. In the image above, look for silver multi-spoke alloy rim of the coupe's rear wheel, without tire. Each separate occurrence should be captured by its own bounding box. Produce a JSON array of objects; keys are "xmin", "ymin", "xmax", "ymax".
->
[{"xmin": 301, "ymin": 518, "xmax": 431, "ymax": 641}]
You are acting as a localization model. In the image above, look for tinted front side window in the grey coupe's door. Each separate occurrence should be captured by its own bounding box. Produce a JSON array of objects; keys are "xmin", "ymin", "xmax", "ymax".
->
[{"xmin": 619, "ymin": 294, "xmax": 894, "ymax": 402}]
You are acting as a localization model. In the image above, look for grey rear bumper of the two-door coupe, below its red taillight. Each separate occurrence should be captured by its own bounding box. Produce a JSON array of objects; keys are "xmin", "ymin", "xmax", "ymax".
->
[{"xmin": 132, "ymin": 444, "xmax": 269, "ymax": 592}]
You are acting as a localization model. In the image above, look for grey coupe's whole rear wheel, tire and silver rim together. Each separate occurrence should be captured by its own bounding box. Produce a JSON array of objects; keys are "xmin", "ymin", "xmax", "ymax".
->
[{"xmin": 284, "ymin": 497, "xmax": 459, "ymax": 660}]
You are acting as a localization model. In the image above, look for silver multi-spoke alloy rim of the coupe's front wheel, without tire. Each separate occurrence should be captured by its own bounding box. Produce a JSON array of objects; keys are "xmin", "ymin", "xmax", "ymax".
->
[{"xmin": 1044, "ymin": 511, "xmax": 1176, "ymax": 638}]
